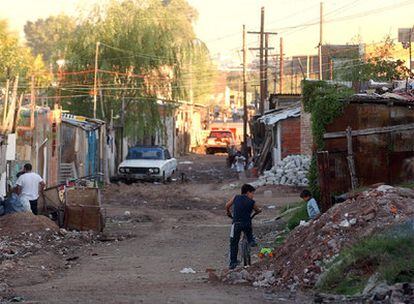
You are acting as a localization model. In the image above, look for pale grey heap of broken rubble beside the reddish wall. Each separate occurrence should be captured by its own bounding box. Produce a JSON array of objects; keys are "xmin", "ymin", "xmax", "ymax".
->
[{"xmin": 251, "ymin": 155, "xmax": 311, "ymax": 187}]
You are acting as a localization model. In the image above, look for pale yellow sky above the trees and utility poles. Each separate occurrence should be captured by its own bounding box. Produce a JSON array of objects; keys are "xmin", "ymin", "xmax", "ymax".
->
[{"xmin": 0, "ymin": 0, "xmax": 414, "ymax": 66}]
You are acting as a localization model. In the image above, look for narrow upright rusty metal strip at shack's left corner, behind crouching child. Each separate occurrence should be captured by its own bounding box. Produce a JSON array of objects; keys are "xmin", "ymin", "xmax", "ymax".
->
[{"xmin": 317, "ymin": 151, "xmax": 332, "ymax": 212}]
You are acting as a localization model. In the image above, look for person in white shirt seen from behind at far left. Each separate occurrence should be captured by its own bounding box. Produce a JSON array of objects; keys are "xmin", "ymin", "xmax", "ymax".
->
[{"xmin": 16, "ymin": 164, "xmax": 45, "ymax": 215}]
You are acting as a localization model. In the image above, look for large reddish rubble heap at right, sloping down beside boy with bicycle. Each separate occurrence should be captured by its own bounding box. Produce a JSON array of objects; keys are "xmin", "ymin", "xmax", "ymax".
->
[{"xmin": 223, "ymin": 185, "xmax": 414, "ymax": 289}]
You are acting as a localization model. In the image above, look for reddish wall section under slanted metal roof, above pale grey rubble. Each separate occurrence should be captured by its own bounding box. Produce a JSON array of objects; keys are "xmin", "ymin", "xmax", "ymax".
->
[{"xmin": 281, "ymin": 117, "xmax": 301, "ymax": 159}]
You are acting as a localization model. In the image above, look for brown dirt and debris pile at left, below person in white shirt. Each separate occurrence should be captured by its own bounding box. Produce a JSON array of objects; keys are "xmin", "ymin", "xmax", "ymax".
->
[{"xmin": 0, "ymin": 212, "xmax": 108, "ymax": 303}]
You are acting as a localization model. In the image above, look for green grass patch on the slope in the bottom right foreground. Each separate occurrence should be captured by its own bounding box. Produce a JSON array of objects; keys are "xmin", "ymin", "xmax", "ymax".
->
[{"xmin": 317, "ymin": 222, "xmax": 414, "ymax": 295}]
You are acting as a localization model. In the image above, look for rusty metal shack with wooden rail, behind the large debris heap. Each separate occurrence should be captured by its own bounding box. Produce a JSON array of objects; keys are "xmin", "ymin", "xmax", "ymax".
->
[{"xmin": 320, "ymin": 94, "xmax": 414, "ymax": 193}]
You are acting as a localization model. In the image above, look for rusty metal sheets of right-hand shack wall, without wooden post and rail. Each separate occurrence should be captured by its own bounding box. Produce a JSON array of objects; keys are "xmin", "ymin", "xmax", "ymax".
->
[{"xmin": 325, "ymin": 103, "xmax": 414, "ymax": 193}]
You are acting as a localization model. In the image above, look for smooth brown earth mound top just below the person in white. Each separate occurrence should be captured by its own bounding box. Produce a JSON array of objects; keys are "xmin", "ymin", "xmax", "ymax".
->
[{"xmin": 0, "ymin": 212, "xmax": 59, "ymax": 236}]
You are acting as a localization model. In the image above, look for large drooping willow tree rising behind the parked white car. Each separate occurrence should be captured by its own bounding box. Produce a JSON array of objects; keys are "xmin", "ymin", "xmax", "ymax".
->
[{"xmin": 25, "ymin": 0, "xmax": 214, "ymax": 140}]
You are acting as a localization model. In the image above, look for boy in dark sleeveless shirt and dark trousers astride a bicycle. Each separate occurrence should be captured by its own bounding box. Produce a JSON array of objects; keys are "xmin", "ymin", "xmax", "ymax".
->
[{"xmin": 226, "ymin": 184, "xmax": 262, "ymax": 269}]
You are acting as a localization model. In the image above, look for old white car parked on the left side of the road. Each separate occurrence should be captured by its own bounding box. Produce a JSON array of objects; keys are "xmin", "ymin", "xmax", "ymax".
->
[{"xmin": 118, "ymin": 146, "xmax": 177, "ymax": 182}]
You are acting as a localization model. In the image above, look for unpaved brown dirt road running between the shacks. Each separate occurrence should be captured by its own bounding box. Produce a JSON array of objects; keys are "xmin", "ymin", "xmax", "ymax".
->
[{"xmin": 9, "ymin": 156, "xmax": 308, "ymax": 303}]
